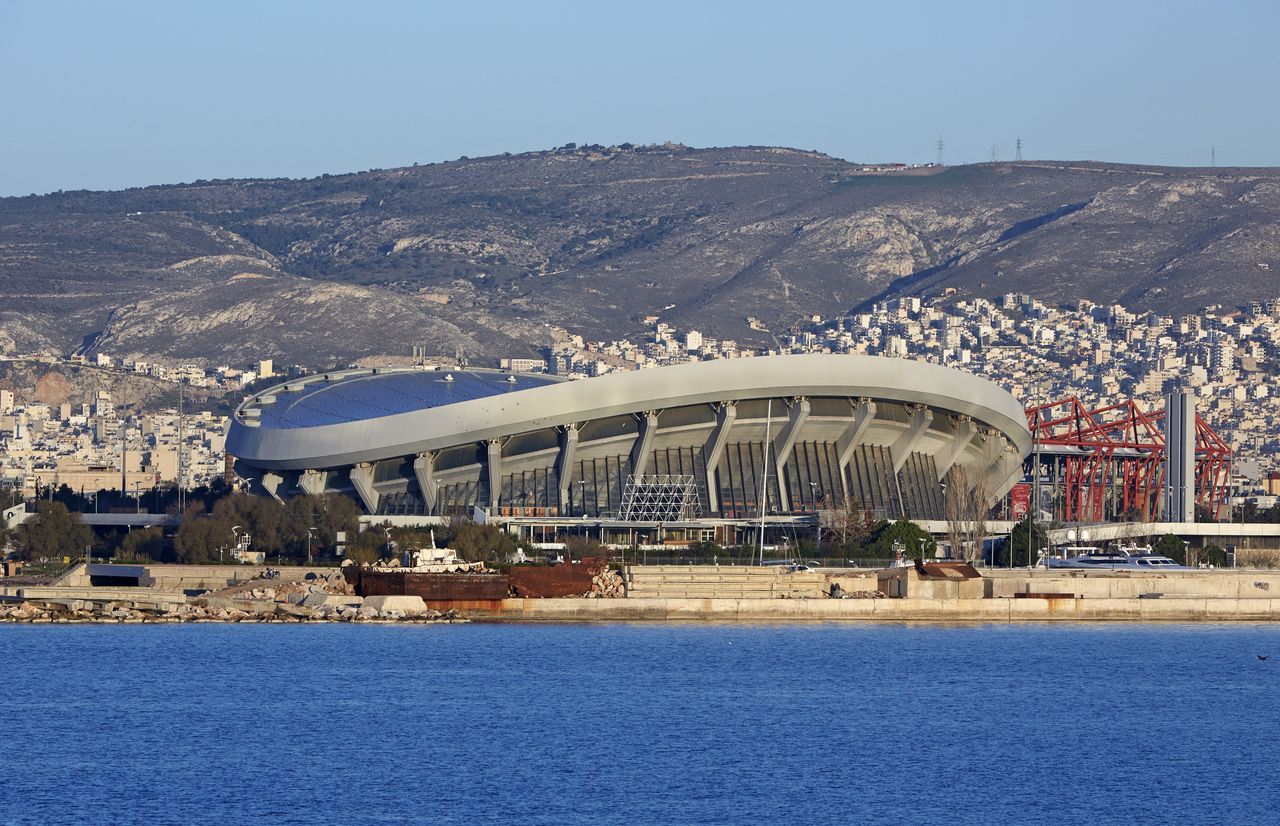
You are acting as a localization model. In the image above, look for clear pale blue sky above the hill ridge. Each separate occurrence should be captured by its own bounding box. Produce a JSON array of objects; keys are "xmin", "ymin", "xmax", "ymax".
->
[{"xmin": 0, "ymin": 0, "xmax": 1280, "ymax": 195}]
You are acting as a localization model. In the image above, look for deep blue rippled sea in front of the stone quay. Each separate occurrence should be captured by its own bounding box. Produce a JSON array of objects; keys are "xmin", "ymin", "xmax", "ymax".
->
[{"xmin": 0, "ymin": 624, "xmax": 1280, "ymax": 825}]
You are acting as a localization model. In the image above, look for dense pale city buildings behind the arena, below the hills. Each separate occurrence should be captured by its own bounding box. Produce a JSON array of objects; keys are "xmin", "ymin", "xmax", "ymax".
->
[{"xmin": 0, "ymin": 293, "xmax": 1280, "ymax": 506}]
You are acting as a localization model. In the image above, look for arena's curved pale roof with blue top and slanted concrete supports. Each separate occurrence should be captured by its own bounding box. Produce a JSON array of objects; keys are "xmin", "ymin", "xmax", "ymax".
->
[{"xmin": 227, "ymin": 355, "xmax": 1030, "ymax": 519}]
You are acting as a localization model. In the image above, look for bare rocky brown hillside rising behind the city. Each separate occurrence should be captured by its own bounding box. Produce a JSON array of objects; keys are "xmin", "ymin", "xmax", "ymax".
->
[{"xmin": 0, "ymin": 145, "xmax": 1280, "ymax": 366}]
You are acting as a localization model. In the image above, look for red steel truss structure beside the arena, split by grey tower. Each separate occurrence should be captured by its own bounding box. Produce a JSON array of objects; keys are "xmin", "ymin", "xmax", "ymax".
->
[{"xmin": 1027, "ymin": 396, "xmax": 1231, "ymax": 521}]
